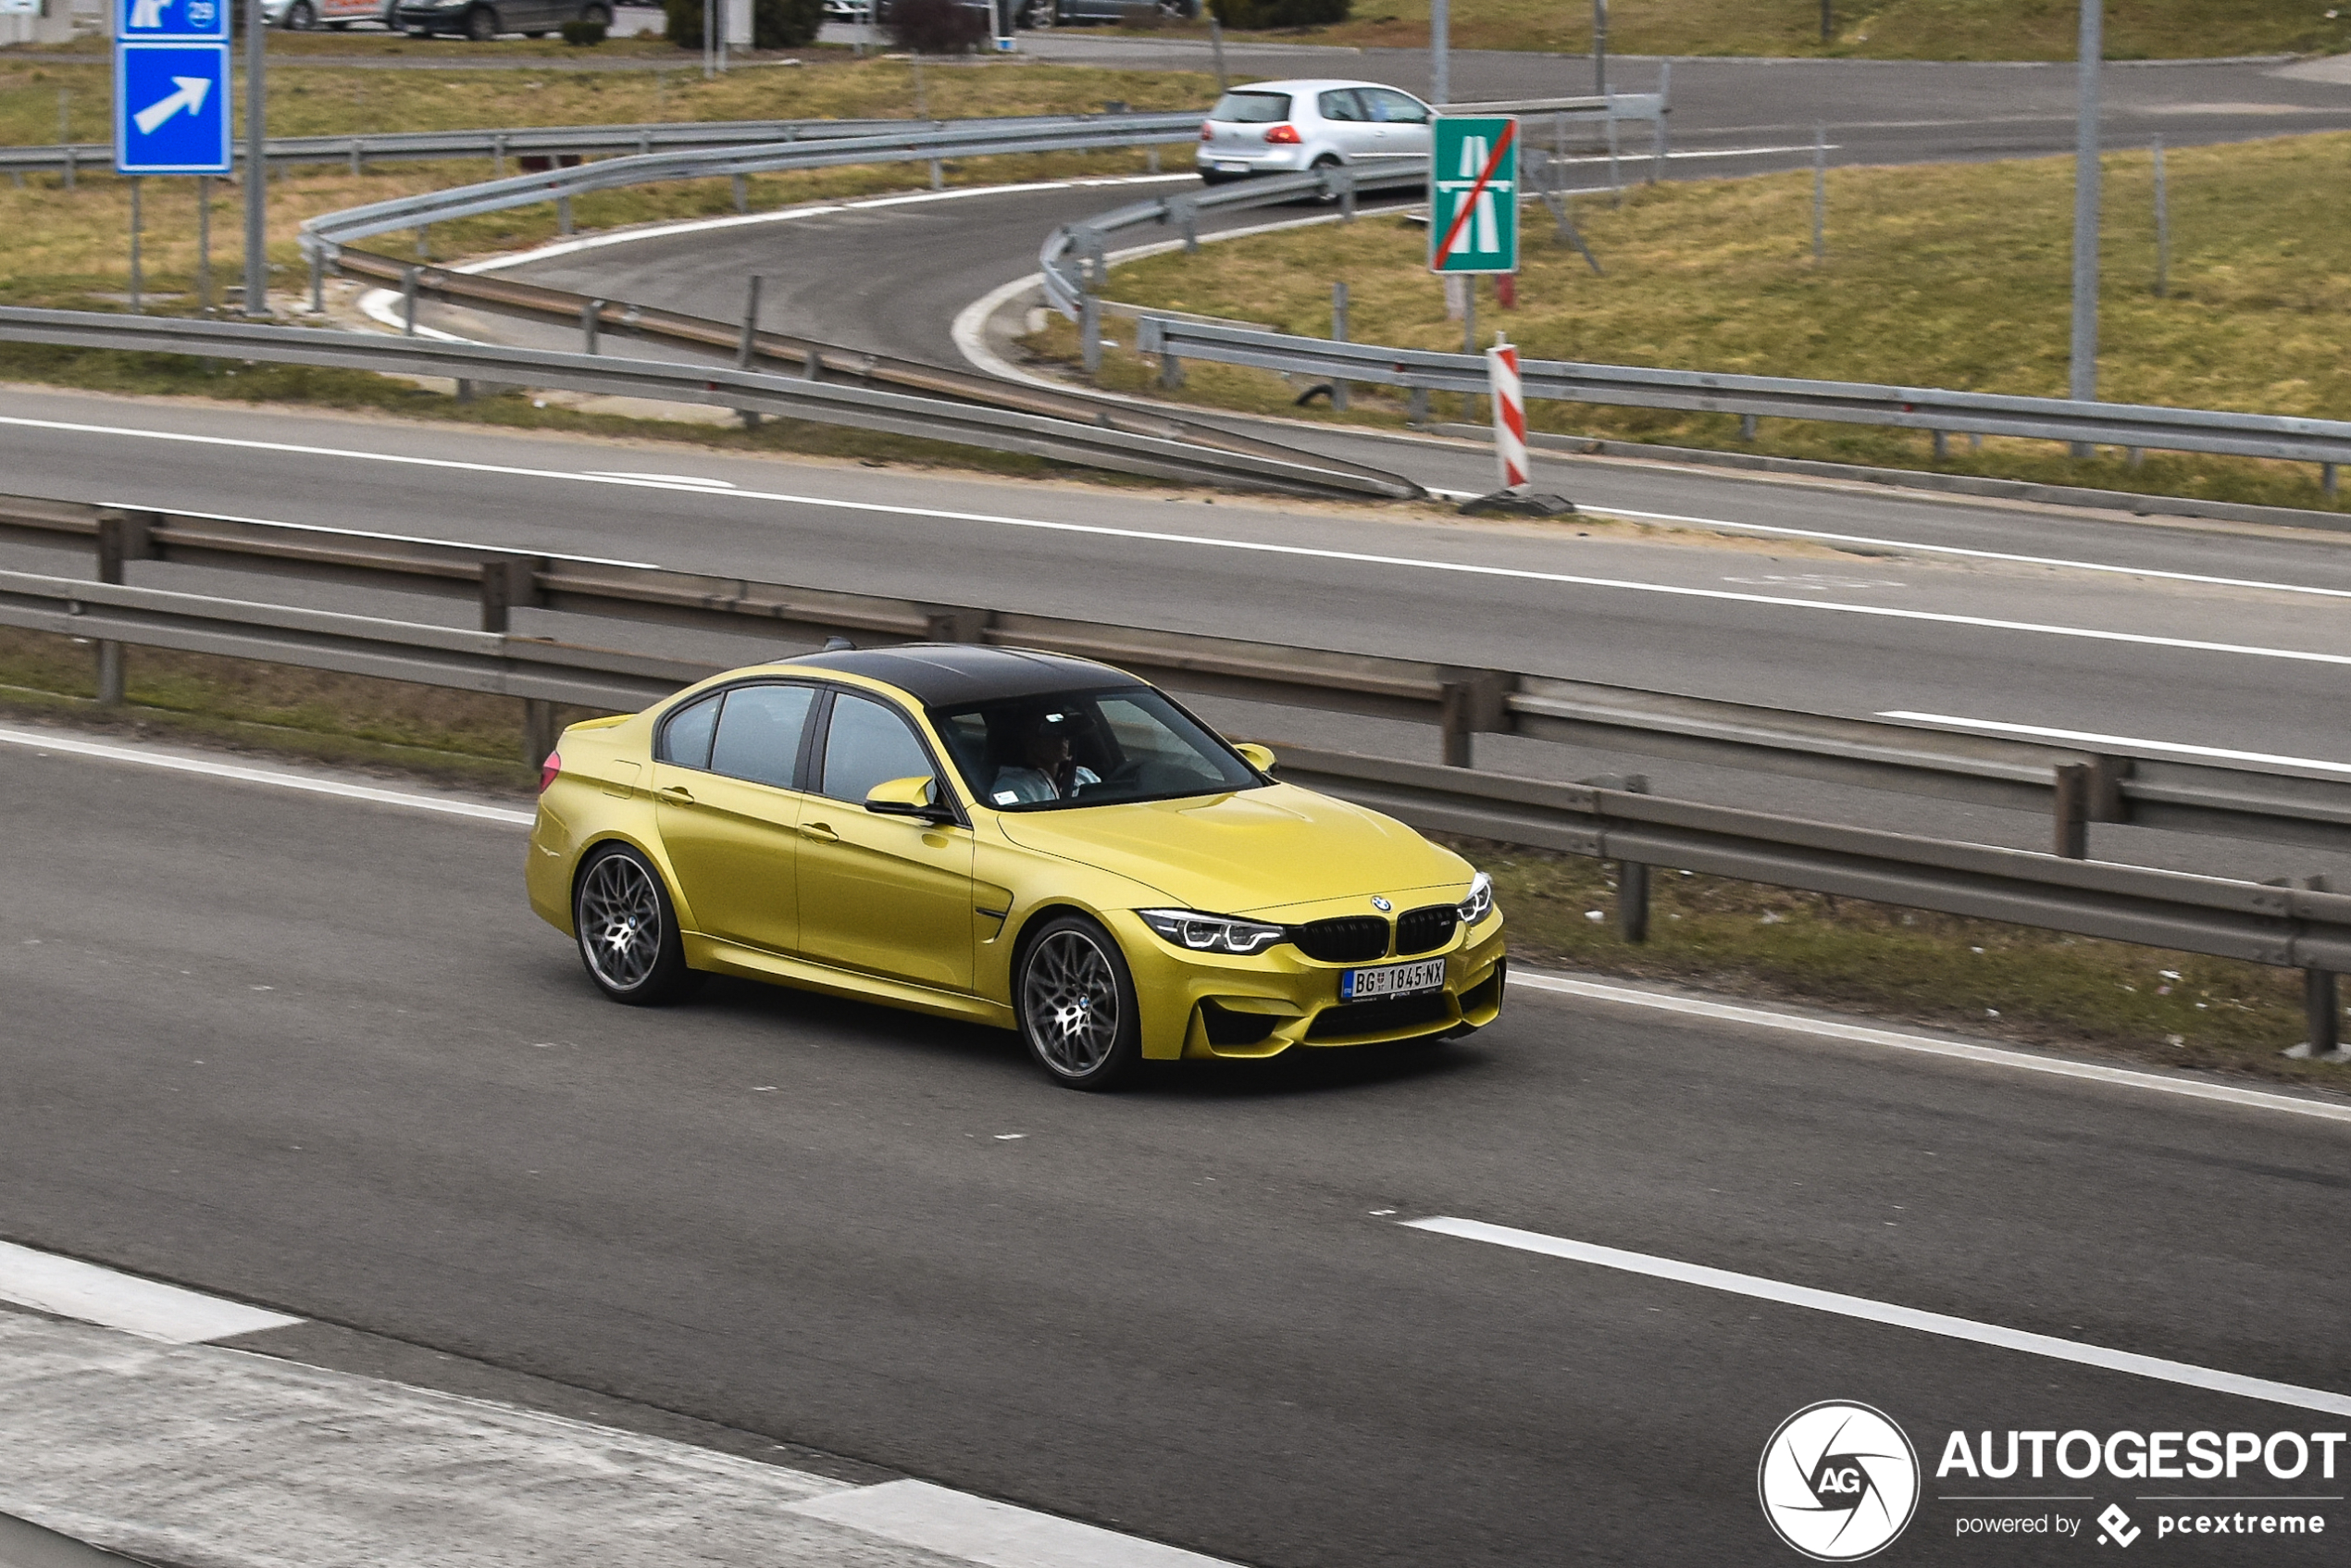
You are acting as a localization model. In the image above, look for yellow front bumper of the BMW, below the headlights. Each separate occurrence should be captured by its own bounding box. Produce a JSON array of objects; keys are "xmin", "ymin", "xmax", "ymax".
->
[{"xmin": 1112, "ymin": 912, "xmax": 1507, "ymax": 1058}]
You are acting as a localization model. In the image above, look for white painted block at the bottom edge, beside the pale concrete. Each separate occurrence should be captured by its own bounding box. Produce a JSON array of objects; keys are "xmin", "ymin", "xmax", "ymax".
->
[{"xmin": 783, "ymin": 1481, "xmax": 1232, "ymax": 1568}]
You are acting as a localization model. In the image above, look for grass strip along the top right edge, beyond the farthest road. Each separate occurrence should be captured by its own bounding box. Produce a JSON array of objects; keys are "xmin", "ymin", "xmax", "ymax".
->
[{"xmin": 1156, "ymin": 0, "xmax": 2351, "ymax": 58}]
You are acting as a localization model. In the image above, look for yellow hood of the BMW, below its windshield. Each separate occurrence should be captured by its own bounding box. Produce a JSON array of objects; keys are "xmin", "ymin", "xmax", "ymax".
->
[{"xmin": 997, "ymin": 783, "xmax": 1472, "ymax": 915}]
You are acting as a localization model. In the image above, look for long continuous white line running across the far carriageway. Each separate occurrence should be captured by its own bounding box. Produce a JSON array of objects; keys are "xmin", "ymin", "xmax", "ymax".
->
[{"xmin": 0, "ymin": 417, "xmax": 2351, "ymax": 666}]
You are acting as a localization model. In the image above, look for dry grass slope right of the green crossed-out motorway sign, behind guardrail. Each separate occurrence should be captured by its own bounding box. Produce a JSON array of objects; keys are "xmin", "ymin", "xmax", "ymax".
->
[{"xmin": 1030, "ymin": 134, "xmax": 2351, "ymax": 508}]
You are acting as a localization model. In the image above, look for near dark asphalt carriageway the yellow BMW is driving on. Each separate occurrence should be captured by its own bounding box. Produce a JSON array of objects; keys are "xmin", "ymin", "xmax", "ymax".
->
[{"xmin": 0, "ymin": 745, "xmax": 2351, "ymax": 1568}]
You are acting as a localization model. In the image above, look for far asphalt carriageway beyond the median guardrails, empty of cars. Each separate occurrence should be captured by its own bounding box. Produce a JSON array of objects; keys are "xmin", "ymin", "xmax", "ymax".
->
[{"xmin": 0, "ymin": 382, "xmax": 2351, "ymax": 877}]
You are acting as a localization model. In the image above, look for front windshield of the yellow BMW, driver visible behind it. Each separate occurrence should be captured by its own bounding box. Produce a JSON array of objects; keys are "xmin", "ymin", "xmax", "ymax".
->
[{"xmin": 931, "ymin": 687, "xmax": 1265, "ymax": 811}]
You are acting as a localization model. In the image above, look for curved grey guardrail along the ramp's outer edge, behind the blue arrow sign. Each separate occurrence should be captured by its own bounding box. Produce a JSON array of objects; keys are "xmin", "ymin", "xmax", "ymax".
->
[{"xmin": 301, "ymin": 113, "xmax": 1199, "ymax": 261}]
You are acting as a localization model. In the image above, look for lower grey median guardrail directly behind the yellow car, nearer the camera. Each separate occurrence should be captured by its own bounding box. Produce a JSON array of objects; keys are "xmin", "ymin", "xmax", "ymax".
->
[{"xmin": 0, "ymin": 556, "xmax": 2351, "ymax": 1025}]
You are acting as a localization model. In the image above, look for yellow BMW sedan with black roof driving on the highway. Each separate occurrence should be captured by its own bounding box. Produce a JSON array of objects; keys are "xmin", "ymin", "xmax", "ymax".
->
[{"xmin": 529, "ymin": 644, "xmax": 1507, "ymax": 1089}]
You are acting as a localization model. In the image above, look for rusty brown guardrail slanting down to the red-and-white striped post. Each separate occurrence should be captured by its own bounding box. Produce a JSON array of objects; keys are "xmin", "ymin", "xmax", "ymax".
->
[{"xmin": 336, "ymin": 249, "xmax": 1423, "ymax": 501}]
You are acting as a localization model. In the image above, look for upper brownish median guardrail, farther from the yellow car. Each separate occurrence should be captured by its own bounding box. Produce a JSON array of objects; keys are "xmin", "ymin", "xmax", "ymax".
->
[{"xmin": 0, "ymin": 496, "xmax": 2351, "ymax": 858}]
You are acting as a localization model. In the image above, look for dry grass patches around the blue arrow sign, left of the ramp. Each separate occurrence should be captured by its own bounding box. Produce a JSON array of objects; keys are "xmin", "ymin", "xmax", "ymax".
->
[{"xmin": 0, "ymin": 50, "xmax": 1215, "ymax": 460}]
